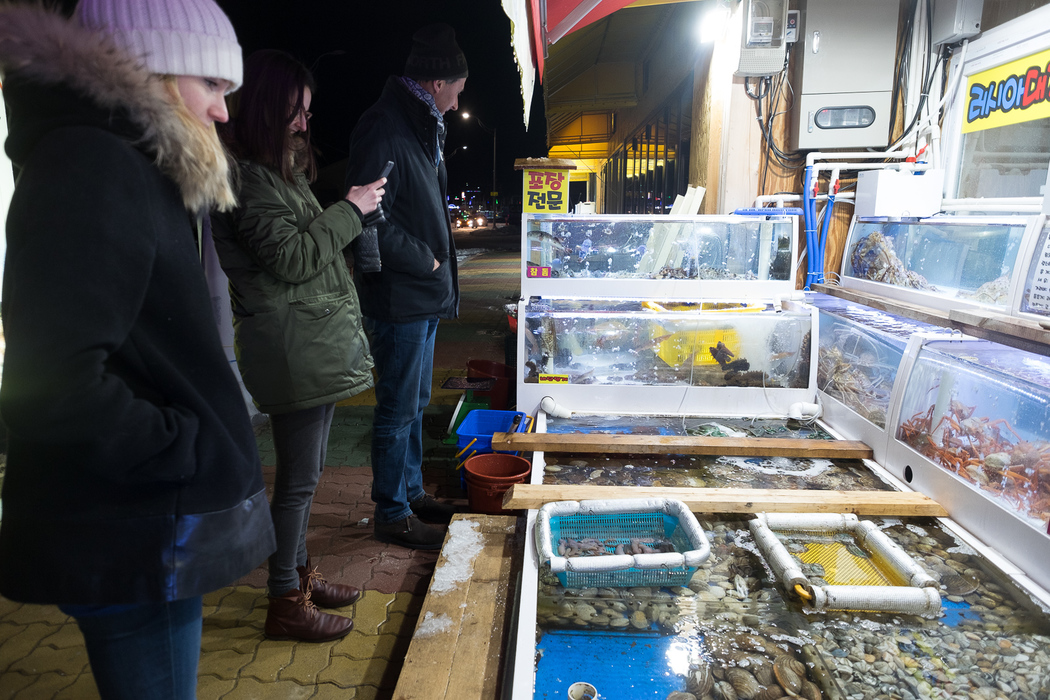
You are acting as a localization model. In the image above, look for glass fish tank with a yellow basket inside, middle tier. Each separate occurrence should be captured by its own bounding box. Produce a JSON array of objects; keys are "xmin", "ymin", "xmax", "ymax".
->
[{"xmin": 519, "ymin": 298, "xmax": 813, "ymax": 388}]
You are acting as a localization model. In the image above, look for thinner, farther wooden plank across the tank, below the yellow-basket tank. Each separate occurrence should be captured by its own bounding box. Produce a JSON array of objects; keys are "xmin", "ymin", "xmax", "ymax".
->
[{"xmin": 492, "ymin": 432, "xmax": 873, "ymax": 460}]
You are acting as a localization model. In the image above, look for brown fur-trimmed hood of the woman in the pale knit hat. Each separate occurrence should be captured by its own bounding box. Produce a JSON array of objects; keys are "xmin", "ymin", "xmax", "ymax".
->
[{"xmin": 0, "ymin": 4, "xmax": 235, "ymax": 212}]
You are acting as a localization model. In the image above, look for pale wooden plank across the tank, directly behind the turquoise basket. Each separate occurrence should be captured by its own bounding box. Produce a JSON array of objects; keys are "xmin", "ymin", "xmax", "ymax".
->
[{"xmin": 495, "ymin": 484, "xmax": 948, "ymax": 517}]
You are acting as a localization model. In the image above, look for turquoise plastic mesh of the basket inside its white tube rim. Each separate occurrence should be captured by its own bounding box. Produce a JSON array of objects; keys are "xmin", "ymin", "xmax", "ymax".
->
[{"xmin": 550, "ymin": 512, "xmax": 696, "ymax": 588}]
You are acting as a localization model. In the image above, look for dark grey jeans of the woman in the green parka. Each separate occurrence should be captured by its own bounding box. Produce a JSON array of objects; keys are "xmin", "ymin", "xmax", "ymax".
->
[{"xmin": 267, "ymin": 403, "xmax": 335, "ymax": 597}]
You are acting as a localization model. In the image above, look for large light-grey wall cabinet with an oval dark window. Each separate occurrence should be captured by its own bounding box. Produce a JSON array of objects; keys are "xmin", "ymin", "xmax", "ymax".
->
[{"xmin": 788, "ymin": 0, "xmax": 900, "ymax": 150}]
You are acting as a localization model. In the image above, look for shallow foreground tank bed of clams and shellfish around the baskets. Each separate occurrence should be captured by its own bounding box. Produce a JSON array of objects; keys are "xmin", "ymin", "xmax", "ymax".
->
[{"xmin": 529, "ymin": 514, "xmax": 1050, "ymax": 700}]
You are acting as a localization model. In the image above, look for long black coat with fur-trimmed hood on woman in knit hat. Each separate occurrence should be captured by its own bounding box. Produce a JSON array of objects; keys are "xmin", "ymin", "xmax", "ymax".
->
[{"xmin": 0, "ymin": 5, "xmax": 274, "ymax": 603}]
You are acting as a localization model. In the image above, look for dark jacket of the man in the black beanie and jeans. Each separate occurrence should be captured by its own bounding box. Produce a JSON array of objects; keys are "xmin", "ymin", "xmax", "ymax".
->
[{"xmin": 345, "ymin": 77, "xmax": 459, "ymax": 322}]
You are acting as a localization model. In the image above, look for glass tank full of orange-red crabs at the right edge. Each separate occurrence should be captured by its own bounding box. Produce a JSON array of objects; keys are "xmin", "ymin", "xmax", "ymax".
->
[{"xmin": 896, "ymin": 340, "xmax": 1050, "ymax": 532}]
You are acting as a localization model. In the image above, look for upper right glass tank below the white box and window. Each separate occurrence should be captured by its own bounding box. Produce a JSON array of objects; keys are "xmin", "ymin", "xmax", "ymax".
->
[{"xmin": 842, "ymin": 217, "xmax": 1028, "ymax": 309}]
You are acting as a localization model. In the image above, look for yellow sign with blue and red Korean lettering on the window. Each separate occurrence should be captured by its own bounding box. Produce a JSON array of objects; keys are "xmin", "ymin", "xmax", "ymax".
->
[{"xmin": 963, "ymin": 48, "xmax": 1050, "ymax": 133}]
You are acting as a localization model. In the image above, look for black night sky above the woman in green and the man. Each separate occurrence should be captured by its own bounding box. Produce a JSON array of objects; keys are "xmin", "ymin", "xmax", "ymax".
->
[{"xmin": 216, "ymin": 0, "xmax": 546, "ymax": 205}]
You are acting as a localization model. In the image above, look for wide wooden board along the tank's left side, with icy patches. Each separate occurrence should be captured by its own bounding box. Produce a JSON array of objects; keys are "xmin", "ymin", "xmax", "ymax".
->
[{"xmin": 393, "ymin": 513, "xmax": 520, "ymax": 700}]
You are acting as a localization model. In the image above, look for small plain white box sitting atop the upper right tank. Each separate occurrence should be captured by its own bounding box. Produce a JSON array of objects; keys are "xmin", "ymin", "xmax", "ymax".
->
[{"xmin": 854, "ymin": 169, "xmax": 944, "ymax": 218}]
